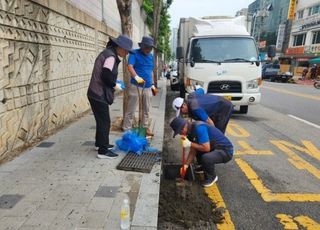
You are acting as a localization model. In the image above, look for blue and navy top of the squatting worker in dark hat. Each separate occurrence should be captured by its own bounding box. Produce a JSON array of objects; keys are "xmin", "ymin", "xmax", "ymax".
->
[{"xmin": 188, "ymin": 122, "xmax": 233, "ymax": 155}]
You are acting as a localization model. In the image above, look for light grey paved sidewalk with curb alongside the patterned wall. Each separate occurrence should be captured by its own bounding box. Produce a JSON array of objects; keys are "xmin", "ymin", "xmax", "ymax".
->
[{"xmin": 0, "ymin": 79, "xmax": 166, "ymax": 230}]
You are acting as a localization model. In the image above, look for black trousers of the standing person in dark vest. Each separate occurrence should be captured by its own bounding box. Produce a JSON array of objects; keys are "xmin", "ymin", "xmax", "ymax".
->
[{"xmin": 88, "ymin": 98, "xmax": 110, "ymax": 154}]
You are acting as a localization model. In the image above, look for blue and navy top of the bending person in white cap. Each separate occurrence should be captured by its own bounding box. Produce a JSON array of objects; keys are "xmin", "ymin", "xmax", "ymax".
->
[{"xmin": 187, "ymin": 94, "xmax": 232, "ymax": 122}]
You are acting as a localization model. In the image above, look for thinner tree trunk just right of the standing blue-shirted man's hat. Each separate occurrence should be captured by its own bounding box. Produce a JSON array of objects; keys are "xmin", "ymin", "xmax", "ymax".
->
[{"xmin": 152, "ymin": 0, "xmax": 162, "ymax": 86}]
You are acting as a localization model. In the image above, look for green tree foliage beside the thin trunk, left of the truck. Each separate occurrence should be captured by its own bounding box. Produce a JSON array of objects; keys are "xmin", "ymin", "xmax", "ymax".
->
[{"xmin": 142, "ymin": 0, "xmax": 173, "ymax": 60}]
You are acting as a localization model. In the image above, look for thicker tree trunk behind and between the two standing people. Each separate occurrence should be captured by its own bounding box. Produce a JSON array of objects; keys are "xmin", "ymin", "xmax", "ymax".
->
[{"xmin": 117, "ymin": 0, "xmax": 132, "ymax": 117}]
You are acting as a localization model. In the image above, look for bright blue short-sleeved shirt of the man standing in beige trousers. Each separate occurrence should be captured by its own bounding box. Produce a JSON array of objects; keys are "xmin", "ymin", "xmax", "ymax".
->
[{"xmin": 128, "ymin": 49, "xmax": 153, "ymax": 88}]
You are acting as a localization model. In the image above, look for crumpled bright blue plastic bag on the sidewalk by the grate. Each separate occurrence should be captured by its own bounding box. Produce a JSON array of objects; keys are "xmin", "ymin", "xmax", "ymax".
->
[{"xmin": 116, "ymin": 131, "xmax": 149, "ymax": 155}]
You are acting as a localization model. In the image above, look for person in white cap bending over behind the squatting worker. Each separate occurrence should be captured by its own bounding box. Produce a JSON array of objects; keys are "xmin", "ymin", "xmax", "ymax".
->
[{"xmin": 172, "ymin": 93, "xmax": 233, "ymax": 133}]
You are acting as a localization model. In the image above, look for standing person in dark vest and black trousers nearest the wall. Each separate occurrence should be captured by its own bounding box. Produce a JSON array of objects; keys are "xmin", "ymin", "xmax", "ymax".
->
[{"xmin": 87, "ymin": 35, "xmax": 132, "ymax": 159}]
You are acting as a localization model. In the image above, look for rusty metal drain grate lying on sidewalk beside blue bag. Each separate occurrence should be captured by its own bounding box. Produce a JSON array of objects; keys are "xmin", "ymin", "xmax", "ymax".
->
[{"xmin": 117, "ymin": 152, "xmax": 158, "ymax": 173}]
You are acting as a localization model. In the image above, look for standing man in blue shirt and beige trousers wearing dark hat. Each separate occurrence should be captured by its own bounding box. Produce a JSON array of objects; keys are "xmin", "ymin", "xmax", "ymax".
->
[{"xmin": 122, "ymin": 36, "xmax": 156, "ymax": 136}]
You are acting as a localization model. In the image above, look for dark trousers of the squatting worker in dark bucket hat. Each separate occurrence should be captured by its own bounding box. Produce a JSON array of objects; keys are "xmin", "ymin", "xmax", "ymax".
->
[{"xmin": 197, "ymin": 149, "xmax": 232, "ymax": 179}]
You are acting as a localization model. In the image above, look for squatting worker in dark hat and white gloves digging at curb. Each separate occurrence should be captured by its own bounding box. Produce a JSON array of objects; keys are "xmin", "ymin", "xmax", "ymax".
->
[{"xmin": 170, "ymin": 117, "xmax": 233, "ymax": 187}]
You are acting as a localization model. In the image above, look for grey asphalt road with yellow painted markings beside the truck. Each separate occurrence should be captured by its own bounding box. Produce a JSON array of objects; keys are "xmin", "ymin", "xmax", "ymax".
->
[{"xmin": 164, "ymin": 83, "xmax": 320, "ymax": 230}]
